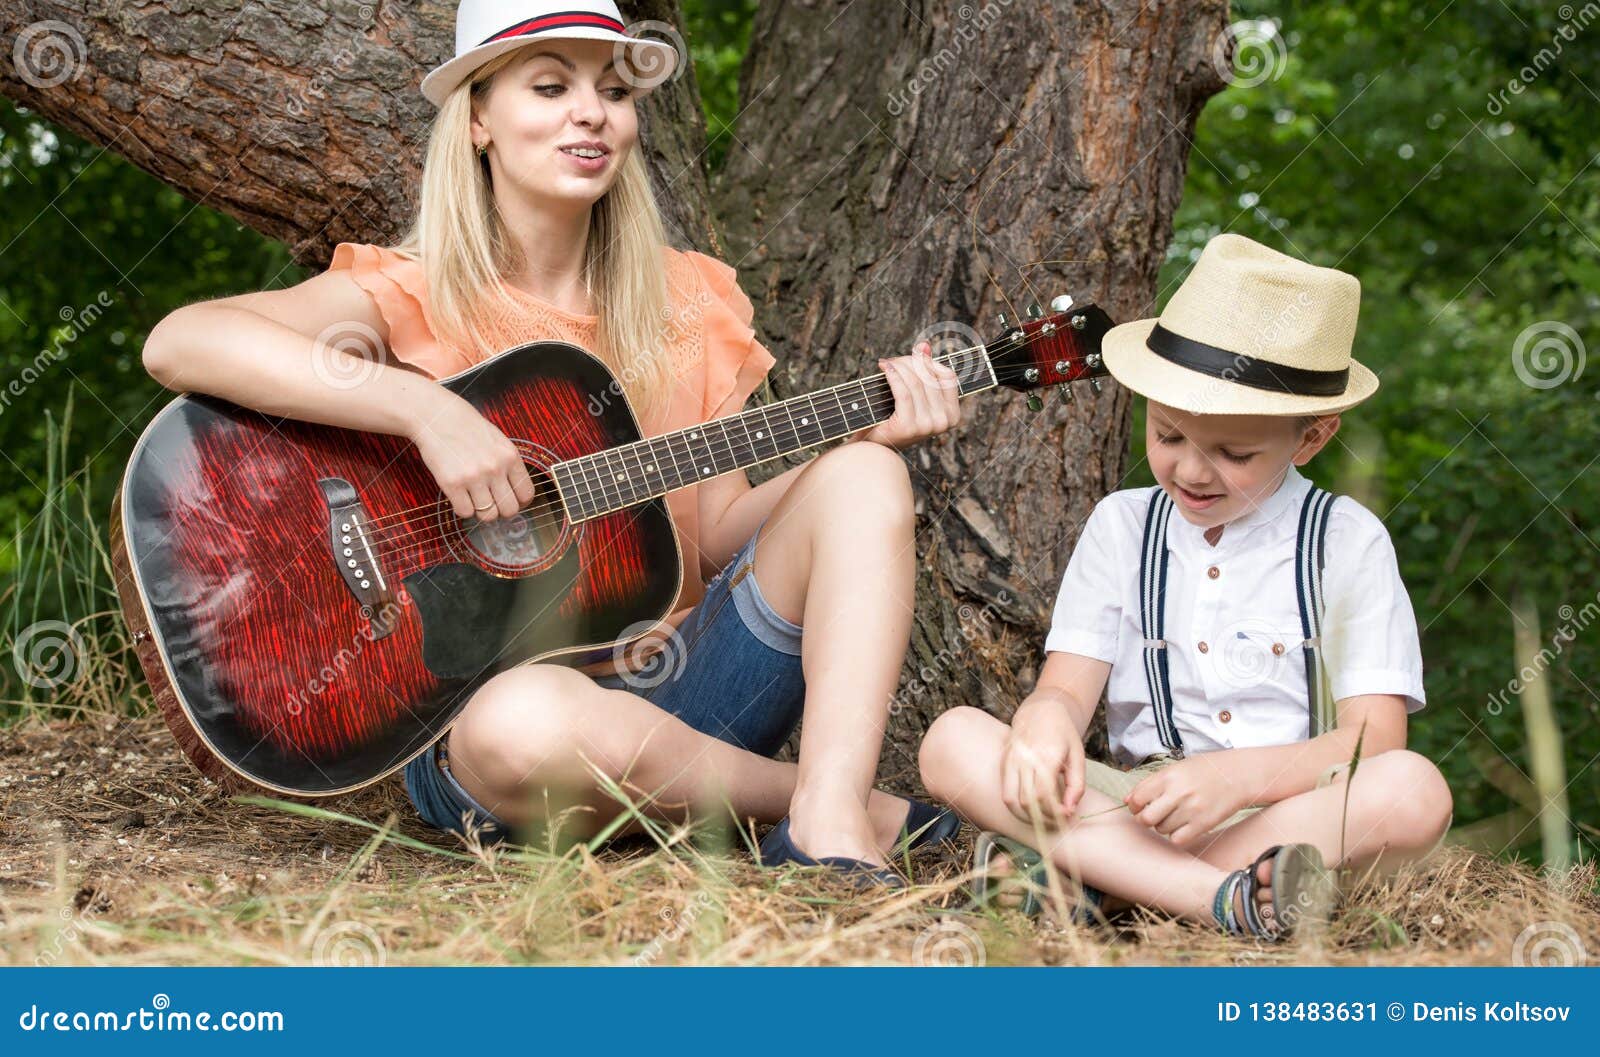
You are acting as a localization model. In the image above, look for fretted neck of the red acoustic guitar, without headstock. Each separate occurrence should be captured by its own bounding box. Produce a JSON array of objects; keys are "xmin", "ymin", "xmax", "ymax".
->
[{"xmin": 550, "ymin": 345, "xmax": 997, "ymax": 521}]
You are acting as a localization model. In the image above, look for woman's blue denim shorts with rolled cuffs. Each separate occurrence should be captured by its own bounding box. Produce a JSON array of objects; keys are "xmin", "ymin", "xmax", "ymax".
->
[{"xmin": 405, "ymin": 529, "xmax": 805, "ymax": 843}]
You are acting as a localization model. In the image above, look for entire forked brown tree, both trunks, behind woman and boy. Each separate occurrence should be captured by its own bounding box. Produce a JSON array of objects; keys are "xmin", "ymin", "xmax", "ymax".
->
[{"xmin": 0, "ymin": 0, "xmax": 1227, "ymax": 779}]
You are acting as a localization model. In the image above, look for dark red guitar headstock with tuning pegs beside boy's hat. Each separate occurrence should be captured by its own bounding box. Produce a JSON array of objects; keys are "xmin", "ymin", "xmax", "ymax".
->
[{"xmin": 987, "ymin": 294, "xmax": 1114, "ymax": 411}]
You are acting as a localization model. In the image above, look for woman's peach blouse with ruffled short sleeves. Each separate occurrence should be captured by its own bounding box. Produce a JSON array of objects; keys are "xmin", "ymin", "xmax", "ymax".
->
[{"xmin": 330, "ymin": 243, "xmax": 773, "ymax": 642}]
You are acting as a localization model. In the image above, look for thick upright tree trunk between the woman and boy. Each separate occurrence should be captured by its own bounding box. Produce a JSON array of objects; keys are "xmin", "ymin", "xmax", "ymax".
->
[{"xmin": 714, "ymin": 0, "xmax": 1227, "ymax": 780}]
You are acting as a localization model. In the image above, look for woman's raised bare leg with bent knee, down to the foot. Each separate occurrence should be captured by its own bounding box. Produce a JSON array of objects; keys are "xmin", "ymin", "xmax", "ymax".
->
[{"xmin": 736, "ymin": 443, "xmax": 915, "ymax": 864}]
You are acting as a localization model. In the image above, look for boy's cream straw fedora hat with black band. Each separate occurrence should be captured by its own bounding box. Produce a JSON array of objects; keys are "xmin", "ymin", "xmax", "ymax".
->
[{"xmin": 1102, "ymin": 235, "xmax": 1378, "ymax": 414}]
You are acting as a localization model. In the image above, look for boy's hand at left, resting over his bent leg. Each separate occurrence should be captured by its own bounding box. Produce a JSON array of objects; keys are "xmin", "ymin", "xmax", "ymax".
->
[{"xmin": 1000, "ymin": 696, "xmax": 1083, "ymax": 827}]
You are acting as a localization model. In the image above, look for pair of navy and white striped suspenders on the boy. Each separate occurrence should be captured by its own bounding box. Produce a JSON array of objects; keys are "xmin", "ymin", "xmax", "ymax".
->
[{"xmin": 1139, "ymin": 485, "xmax": 1338, "ymax": 760}]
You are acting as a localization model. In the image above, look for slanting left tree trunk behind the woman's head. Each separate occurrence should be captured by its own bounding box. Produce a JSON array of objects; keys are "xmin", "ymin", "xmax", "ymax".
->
[{"xmin": 0, "ymin": 0, "xmax": 712, "ymax": 267}]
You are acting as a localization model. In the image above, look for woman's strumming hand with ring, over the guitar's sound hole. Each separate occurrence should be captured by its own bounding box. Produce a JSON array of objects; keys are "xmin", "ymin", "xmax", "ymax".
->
[{"xmin": 410, "ymin": 385, "xmax": 533, "ymax": 521}]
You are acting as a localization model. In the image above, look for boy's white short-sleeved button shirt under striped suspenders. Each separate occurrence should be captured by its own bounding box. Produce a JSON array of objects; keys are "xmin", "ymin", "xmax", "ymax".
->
[{"xmin": 1045, "ymin": 467, "xmax": 1426, "ymax": 764}]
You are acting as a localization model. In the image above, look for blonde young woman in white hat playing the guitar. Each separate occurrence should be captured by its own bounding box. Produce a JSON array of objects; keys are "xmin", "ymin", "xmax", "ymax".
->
[{"xmin": 144, "ymin": 0, "xmax": 960, "ymax": 881}]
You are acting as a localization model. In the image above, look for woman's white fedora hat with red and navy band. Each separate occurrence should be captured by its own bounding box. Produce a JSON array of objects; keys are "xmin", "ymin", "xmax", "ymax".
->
[{"xmin": 422, "ymin": 0, "xmax": 678, "ymax": 106}]
